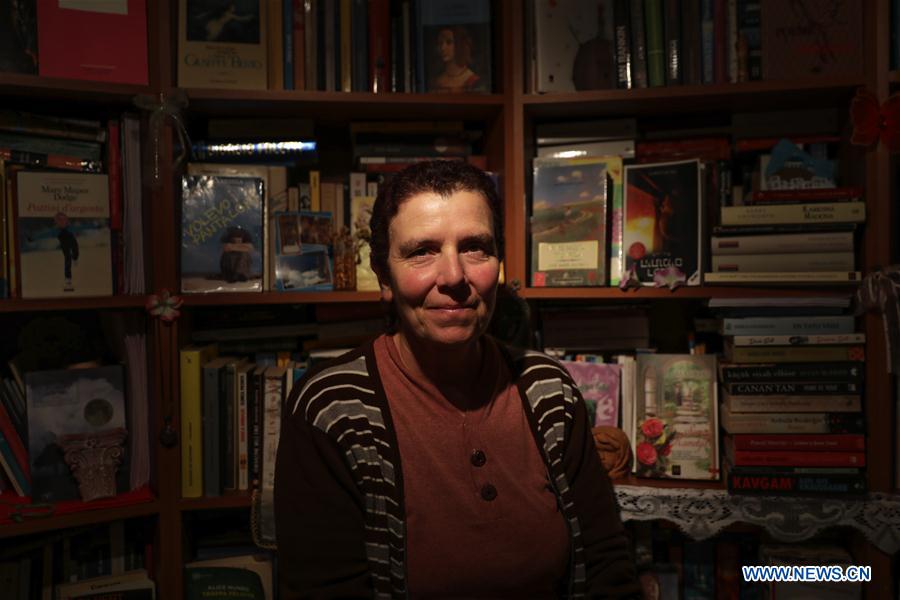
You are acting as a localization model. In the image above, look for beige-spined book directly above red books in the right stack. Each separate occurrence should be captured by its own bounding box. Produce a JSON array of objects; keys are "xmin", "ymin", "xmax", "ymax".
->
[{"xmin": 720, "ymin": 406, "xmax": 866, "ymax": 433}]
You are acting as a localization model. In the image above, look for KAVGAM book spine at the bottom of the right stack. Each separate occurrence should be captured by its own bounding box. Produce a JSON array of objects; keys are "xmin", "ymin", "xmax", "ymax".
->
[{"xmin": 727, "ymin": 470, "xmax": 866, "ymax": 496}]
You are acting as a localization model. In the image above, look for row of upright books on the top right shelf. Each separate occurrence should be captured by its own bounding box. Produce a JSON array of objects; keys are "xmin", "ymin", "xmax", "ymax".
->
[{"xmin": 525, "ymin": 0, "xmax": 862, "ymax": 92}]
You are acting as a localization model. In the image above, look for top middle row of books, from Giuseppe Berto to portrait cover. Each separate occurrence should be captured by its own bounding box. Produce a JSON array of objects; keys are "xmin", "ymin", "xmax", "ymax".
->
[{"xmin": 178, "ymin": 0, "xmax": 493, "ymax": 93}]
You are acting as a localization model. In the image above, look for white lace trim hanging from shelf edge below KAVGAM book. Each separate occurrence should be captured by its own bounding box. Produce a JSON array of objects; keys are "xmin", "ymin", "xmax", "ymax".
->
[{"xmin": 616, "ymin": 485, "xmax": 900, "ymax": 554}]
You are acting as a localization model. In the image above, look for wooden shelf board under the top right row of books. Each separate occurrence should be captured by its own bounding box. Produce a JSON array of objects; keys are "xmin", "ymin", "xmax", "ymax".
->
[{"xmin": 523, "ymin": 77, "xmax": 863, "ymax": 118}]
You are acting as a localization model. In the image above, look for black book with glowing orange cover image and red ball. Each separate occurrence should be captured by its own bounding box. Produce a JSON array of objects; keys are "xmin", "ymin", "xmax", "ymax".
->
[{"xmin": 622, "ymin": 160, "xmax": 703, "ymax": 286}]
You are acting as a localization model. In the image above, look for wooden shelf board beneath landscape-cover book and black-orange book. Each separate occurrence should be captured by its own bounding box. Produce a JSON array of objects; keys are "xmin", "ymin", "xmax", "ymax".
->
[{"xmin": 519, "ymin": 286, "xmax": 853, "ymax": 301}]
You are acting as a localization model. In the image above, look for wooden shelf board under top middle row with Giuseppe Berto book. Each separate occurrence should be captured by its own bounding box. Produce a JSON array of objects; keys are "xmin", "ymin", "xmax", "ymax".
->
[{"xmin": 185, "ymin": 89, "xmax": 504, "ymax": 121}]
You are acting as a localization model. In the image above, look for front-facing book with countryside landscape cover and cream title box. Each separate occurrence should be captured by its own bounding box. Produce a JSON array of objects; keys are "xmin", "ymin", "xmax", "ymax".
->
[{"xmin": 531, "ymin": 158, "xmax": 607, "ymax": 287}]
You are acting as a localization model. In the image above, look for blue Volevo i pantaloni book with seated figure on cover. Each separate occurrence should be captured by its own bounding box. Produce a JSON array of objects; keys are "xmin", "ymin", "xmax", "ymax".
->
[{"xmin": 181, "ymin": 175, "xmax": 264, "ymax": 293}]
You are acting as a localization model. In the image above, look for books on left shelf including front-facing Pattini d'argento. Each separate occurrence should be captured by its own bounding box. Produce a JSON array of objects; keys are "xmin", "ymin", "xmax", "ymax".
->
[{"xmin": 0, "ymin": 111, "xmax": 145, "ymax": 298}]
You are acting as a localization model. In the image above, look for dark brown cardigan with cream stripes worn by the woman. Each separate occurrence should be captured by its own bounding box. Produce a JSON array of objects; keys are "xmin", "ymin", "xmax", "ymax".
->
[{"xmin": 275, "ymin": 343, "xmax": 639, "ymax": 598}]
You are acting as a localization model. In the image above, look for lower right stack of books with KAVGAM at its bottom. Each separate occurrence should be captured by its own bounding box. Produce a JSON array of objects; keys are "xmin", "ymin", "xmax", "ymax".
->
[{"xmin": 719, "ymin": 304, "xmax": 866, "ymax": 494}]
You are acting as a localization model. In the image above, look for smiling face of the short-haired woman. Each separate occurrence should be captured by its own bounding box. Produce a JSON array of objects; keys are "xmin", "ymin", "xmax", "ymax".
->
[{"xmin": 382, "ymin": 191, "xmax": 500, "ymax": 347}]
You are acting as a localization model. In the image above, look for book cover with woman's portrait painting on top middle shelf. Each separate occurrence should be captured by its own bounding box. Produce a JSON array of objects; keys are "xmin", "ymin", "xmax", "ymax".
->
[{"xmin": 415, "ymin": 0, "xmax": 492, "ymax": 93}]
